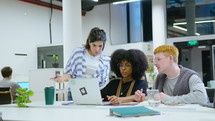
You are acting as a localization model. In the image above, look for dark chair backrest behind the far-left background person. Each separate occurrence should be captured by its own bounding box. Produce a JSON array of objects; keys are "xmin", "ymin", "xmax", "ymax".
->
[{"xmin": 0, "ymin": 87, "xmax": 12, "ymax": 104}]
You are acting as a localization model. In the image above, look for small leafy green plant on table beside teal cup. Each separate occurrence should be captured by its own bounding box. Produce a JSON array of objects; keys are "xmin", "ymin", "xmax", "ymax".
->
[{"xmin": 16, "ymin": 88, "xmax": 34, "ymax": 108}]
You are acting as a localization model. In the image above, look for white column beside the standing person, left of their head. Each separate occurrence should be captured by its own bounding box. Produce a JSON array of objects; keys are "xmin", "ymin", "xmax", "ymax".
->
[{"xmin": 63, "ymin": 0, "xmax": 83, "ymax": 67}]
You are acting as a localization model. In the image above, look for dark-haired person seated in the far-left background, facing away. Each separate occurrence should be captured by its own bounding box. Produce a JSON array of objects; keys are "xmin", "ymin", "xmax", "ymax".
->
[{"xmin": 0, "ymin": 66, "xmax": 20, "ymax": 100}]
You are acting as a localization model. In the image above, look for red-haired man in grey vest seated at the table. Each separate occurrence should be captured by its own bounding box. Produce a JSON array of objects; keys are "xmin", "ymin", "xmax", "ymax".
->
[{"xmin": 136, "ymin": 44, "xmax": 208, "ymax": 105}]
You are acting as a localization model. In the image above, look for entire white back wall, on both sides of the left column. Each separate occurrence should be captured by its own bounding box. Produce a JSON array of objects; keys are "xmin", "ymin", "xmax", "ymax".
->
[{"xmin": 0, "ymin": 0, "xmax": 155, "ymax": 81}]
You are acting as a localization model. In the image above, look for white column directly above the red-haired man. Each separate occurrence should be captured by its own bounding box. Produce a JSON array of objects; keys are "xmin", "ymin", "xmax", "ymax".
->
[{"xmin": 152, "ymin": 0, "xmax": 167, "ymax": 51}]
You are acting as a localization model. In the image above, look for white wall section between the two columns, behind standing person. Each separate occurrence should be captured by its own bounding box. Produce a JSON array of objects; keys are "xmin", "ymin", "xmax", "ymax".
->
[{"xmin": 82, "ymin": 4, "xmax": 152, "ymax": 55}]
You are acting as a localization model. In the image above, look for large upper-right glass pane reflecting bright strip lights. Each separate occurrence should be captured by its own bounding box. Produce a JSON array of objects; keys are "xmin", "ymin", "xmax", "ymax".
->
[{"xmin": 167, "ymin": 0, "xmax": 215, "ymax": 38}]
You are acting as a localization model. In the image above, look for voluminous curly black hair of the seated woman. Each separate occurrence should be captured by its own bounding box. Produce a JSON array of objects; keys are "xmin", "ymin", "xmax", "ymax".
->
[{"xmin": 110, "ymin": 49, "xmax": 148, "ymax": 80}]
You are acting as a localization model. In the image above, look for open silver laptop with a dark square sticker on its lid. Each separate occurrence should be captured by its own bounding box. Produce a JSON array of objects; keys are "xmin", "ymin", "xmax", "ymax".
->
[{"xmin": 69, "ymin": 78, "xmax": 103, "ymax": 105}]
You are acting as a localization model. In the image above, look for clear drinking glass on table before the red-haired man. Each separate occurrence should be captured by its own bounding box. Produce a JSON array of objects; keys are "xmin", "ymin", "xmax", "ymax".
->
[{"xmin": 147, "ymin": 89, "xmax": 161, "ymax": 107}]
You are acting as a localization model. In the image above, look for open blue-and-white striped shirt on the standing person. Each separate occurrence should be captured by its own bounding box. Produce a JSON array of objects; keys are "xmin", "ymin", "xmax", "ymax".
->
[{"xmin": 64, "ymin": 47, "xmax": 110, "ymax": 87}]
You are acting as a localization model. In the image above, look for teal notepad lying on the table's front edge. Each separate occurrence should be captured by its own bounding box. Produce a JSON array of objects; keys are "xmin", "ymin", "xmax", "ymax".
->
[{"xmin": 110, "ymin": 106, "xmax": 160, "ymax": 117}]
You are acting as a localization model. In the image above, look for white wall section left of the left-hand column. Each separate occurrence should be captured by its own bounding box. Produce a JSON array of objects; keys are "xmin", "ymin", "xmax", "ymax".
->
[{"xmin": 0, "ymin": 0, "xmax": 62, "ymax": 81}]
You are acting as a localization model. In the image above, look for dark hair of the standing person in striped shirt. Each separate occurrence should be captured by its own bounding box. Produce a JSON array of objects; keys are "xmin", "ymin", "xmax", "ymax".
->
[{"xmin": 85, "ymin": 27, "xmax": 106, "ymax": 50}]
